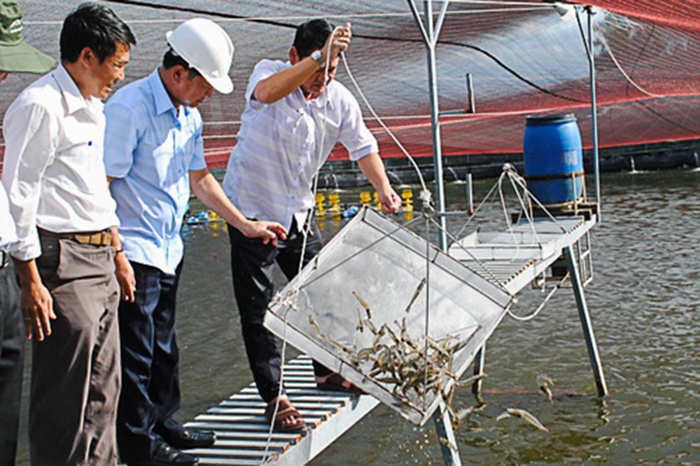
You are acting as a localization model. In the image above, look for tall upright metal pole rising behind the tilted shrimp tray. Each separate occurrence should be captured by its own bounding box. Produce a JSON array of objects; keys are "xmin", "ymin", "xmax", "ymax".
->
[{"xmin": 424, "ymin": 0, "xmax": 447, "ymax": 251}]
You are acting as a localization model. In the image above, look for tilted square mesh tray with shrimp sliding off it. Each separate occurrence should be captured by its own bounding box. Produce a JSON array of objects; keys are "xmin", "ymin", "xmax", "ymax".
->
[{"xmin": 265, "ymin": 209, "xmax": 511, "ymax": 424}]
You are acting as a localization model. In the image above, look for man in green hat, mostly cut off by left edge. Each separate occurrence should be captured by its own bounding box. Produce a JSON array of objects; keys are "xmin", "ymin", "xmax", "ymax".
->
[{"xmin": 0, "ymin": 0, "xmax": 56, "ymax": 465}]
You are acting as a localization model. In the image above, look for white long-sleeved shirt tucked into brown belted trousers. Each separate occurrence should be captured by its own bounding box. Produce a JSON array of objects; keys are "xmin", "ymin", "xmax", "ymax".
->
[{"xmin": 2, "ymin": 65, "xmax": 118, "ymax": 260}]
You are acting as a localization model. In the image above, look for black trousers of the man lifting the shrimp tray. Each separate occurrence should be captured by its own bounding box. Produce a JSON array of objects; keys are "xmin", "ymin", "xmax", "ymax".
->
[{"xmin": 228, "ymin": 219, "xmax": 330, "ymax": 402}]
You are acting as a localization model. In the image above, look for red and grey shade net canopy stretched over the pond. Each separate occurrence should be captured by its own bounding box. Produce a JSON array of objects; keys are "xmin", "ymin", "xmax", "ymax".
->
[{"xmin": 0, "ymin": 0, "xmax": 700, "ymax": 173}]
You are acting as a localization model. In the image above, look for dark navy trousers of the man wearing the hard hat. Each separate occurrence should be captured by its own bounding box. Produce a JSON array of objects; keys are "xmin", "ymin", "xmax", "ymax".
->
[{"xmin": 117, "ymin": 262, "xmax": 182, "ymax": 463}]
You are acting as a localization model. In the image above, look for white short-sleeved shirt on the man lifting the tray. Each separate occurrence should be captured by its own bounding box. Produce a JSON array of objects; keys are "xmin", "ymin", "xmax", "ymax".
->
[{"xmin": 222, "ymin": 60, "xmax": 378, "ymax": 227}]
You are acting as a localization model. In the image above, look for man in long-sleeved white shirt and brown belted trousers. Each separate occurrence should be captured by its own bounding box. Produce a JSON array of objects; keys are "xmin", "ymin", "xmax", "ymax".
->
[{"xmin": 2, "ymin": 3, "xmax": 136, "ymax": 466}]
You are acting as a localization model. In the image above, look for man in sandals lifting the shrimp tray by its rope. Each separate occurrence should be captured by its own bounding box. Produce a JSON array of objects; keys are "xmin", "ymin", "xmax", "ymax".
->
[{"xmin": 223, "ymin": 20, "xmax": 401, "ymax": 430}]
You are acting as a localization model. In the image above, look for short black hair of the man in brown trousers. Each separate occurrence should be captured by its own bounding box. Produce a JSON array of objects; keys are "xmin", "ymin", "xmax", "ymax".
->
[{"xmin": 60, "ymin": 2, "xmax": 136, "ymax": 63}]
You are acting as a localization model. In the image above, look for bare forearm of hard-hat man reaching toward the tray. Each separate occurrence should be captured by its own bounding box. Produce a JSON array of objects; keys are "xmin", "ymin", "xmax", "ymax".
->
[{"xmin": 190, "ymin": 168, "xmax": 287, "ymax": 245}]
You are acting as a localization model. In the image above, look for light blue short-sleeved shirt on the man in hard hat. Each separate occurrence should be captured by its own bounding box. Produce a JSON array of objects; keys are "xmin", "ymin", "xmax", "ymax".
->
[{"xmin": 105, "ymin": 69, "xmax": 206, "ymax": 274}]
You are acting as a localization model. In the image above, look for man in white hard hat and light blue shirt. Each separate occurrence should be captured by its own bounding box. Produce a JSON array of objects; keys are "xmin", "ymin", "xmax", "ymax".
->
[{"xmin": 105, "ymin": 18, "xmax": 286, "ymax": 465}]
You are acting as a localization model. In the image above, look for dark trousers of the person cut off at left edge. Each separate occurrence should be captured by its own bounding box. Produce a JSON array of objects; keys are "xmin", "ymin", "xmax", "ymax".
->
[{"xmin": 0, "ymin": 264, "xmax": 24, "ymax": 466}]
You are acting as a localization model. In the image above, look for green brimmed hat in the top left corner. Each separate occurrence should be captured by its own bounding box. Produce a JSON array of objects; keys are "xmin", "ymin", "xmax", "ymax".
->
[{"xmin": 0, "ymin": 0, "xmax": 56, "ymax": 74}]
